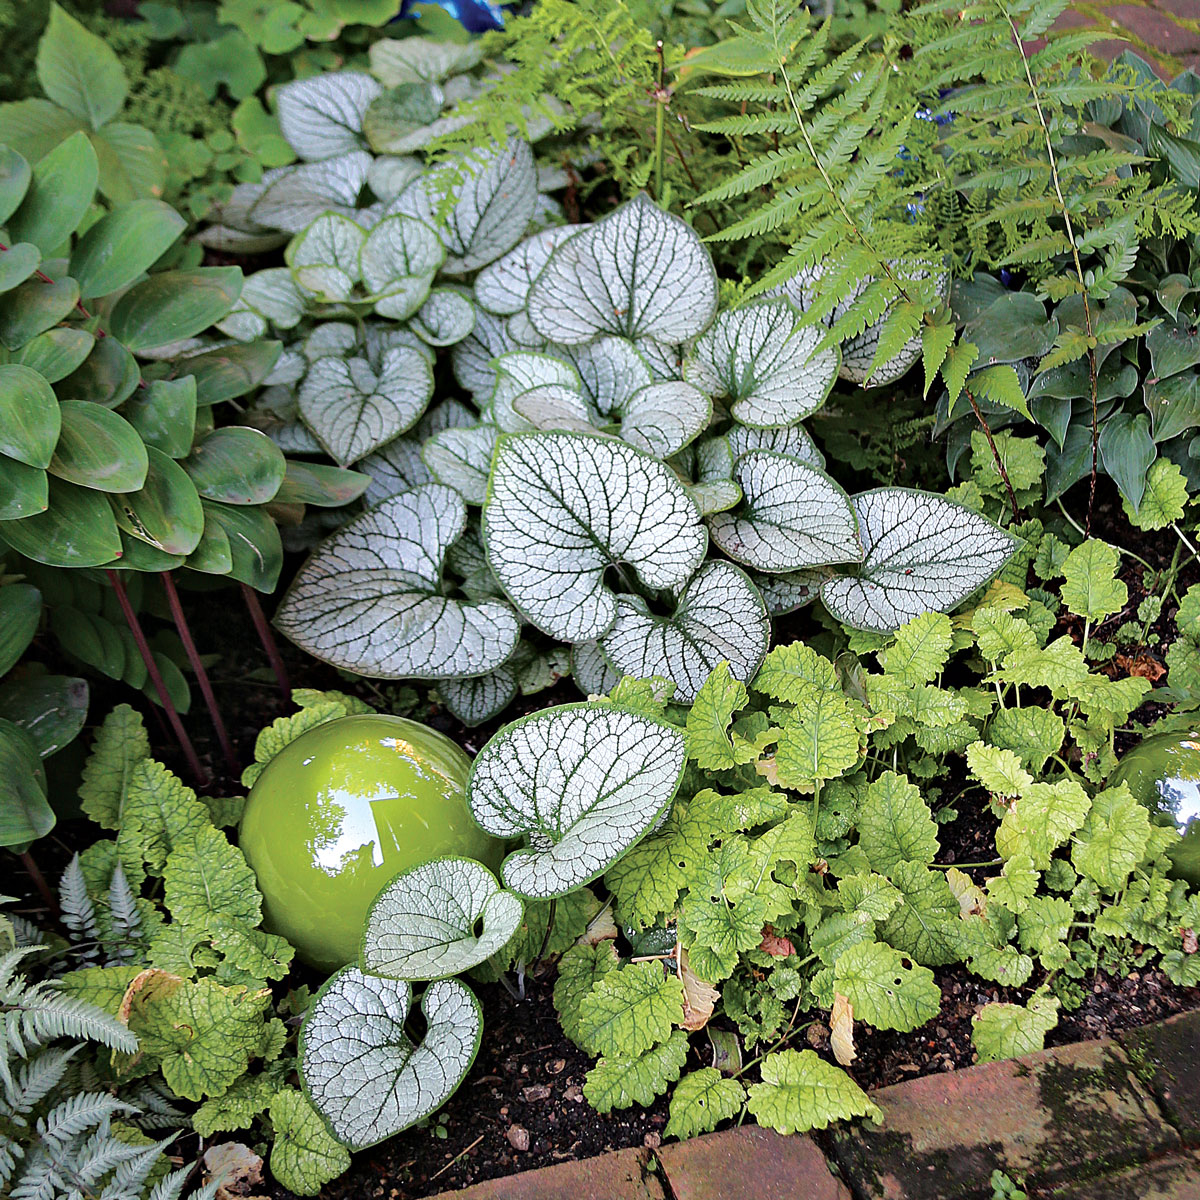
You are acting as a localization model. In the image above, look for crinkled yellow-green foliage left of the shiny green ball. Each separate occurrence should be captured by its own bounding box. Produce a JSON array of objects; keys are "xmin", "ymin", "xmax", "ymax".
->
[{"xmin": 36, "ymin": 692, "xmax": 350, "ymax": 1195}]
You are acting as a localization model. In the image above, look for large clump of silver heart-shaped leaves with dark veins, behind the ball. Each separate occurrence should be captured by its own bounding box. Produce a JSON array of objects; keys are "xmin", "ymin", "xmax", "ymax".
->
[{"xmin": 227, "ymin": 73, "xmax": 1012, "ymax": 721}]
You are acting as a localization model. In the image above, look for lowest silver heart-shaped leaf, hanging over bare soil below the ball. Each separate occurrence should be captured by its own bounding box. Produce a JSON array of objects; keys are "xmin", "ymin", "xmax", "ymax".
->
[{"xmin": 300, "ymin": 967, "xmax": 484, "ymax": 1150}]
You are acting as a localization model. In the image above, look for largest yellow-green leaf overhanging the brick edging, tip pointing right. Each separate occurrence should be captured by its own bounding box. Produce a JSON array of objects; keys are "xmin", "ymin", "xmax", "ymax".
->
[{"xmin": 746, "ymin": 1050, "xmax": 880, "ymax": 1134}]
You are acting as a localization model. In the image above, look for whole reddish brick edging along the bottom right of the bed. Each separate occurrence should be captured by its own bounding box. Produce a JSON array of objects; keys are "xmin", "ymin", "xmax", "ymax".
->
[{"xmin": 434, "ymin": 1012, "xmax": 1200, "ymax": 1200}]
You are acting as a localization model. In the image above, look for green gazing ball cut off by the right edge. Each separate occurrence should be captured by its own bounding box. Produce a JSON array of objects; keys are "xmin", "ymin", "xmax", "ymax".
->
[{"xmin": 1109, "ymin": 730, "xmax": 1200, "ymax": 888}]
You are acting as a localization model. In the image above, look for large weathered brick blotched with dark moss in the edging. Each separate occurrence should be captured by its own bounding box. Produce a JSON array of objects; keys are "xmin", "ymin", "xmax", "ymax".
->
[{"xmin": 835, "ymin": 1042, "xmax": 1180, "ymax": 1200}]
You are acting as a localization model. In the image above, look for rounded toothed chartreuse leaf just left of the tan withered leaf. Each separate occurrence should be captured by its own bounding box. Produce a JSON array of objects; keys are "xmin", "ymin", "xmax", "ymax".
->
[{"xmin": 580, "ymin": 962, "xmax": 683, "ymax": 1057}]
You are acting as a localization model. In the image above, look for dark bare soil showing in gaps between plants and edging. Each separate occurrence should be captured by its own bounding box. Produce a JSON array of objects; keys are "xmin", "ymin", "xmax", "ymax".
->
[{"xmin": 5, "ymin": 477, "xmax": 1200, "ymax": 1200}]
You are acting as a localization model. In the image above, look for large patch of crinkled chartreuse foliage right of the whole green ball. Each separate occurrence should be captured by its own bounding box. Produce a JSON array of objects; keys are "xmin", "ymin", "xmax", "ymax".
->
[{"xmin": 556, "ymin": 549, "xmax": 1200, "ymax": 1136}]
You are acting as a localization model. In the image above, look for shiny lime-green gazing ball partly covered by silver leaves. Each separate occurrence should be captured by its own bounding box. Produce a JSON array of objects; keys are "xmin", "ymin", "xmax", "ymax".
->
[{"xmin": 239, "ymin": 715, "xmax": 503, "ymax": 971}]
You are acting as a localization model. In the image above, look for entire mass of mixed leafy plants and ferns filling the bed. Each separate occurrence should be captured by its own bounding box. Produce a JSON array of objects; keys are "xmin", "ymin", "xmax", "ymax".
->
[{"xmin": 0, "ymin": 0, "xmax": 1200, "ymax": 1200}]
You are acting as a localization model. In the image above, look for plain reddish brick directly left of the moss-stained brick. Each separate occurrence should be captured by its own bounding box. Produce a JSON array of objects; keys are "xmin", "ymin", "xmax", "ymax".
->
[{"xmin": 659, "ymin": 1126, "xmax": 851, "ymax": 1200}]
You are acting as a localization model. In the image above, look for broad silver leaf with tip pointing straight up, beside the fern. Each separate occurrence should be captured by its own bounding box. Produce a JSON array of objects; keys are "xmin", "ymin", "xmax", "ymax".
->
[{"xmin": 529, "ymin": 196, "xmax": 716, "ymax": 346}]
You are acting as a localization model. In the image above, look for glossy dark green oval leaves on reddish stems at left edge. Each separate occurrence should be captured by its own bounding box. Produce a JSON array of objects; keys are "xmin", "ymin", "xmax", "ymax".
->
[{"xmin": 0, "ymin": 118, "xmax": 365, "ymax": 590}]
